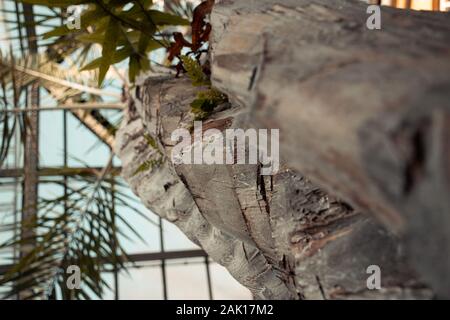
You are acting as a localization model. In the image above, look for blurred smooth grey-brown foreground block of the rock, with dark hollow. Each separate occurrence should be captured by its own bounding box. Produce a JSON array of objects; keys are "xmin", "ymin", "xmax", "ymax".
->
[{"xmin": 211, "ymin": 0, "xmax": 450, "ymax": 297}]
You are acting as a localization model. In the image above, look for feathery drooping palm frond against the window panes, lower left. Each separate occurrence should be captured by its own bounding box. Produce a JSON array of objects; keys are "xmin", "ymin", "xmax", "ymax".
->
[{"xmin": 0, "ymin": 156, "xmax": 156, "ymax": 299}]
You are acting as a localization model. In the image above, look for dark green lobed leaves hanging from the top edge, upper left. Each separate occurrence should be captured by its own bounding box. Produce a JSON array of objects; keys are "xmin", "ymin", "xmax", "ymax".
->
[{"xmin": 21, "ymin": 0, "xmax": 189, "ymax": 85}]
